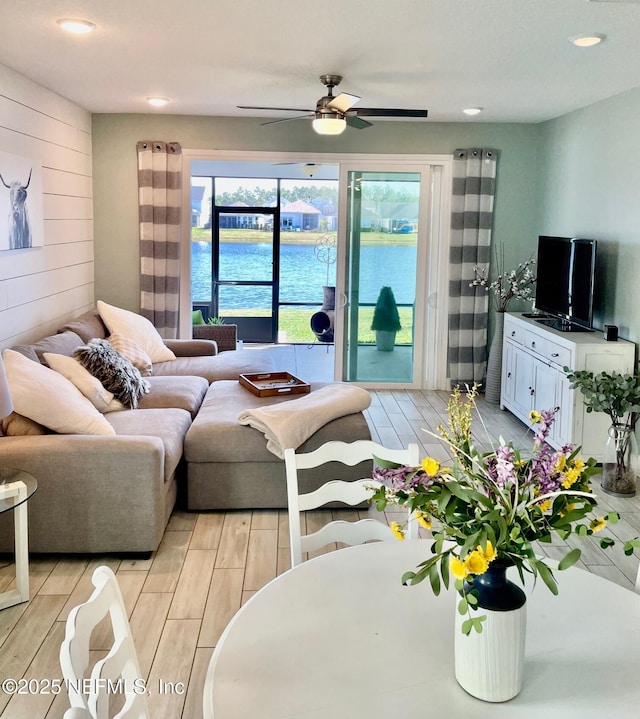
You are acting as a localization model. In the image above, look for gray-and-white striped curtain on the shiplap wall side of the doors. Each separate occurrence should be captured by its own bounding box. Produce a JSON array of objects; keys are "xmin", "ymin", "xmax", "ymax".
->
[{"xmin": 137, "ymin": 141, "xmax": 182, "ymax": 339}]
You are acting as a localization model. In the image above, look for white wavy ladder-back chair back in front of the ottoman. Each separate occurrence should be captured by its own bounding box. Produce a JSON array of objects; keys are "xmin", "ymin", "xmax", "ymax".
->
[{"xmin": 284, "ymin": 440, "xmax": 420, "ymax": 567}]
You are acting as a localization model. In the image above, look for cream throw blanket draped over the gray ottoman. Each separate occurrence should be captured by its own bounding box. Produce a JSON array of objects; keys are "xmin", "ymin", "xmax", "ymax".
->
[{"xmin": 238, "ymin": 384, "xmax": 371, "ymax": 459}]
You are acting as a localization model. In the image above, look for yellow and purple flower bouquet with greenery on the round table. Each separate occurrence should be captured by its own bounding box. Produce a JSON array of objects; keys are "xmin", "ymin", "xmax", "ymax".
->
[{"xmin": 373, "ymin": 385, "xmax": 640, "ymax": 635}]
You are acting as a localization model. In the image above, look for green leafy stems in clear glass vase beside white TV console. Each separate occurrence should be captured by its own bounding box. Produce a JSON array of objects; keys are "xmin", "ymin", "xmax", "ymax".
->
[{"xmin": 564, "ymin": 367, "xmax": 640, "ymax": 497}]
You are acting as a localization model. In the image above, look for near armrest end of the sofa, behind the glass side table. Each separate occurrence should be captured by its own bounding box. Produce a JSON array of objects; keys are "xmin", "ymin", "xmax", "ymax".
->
[{"xmin": 0, "ymin": 435, "xmax": 166, "ymax": 553}]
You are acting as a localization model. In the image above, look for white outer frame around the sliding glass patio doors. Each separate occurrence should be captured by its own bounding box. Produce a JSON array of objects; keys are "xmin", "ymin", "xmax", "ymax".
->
[{"xmin": 179, "ymin": 149, "xmax": 453, "ymax": 390}]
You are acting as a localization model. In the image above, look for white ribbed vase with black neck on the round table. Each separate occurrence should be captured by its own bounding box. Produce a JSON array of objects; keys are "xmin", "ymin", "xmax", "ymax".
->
[{"xmin": 455, "ymin": 559, "xmax": 527, "ymax": 702}]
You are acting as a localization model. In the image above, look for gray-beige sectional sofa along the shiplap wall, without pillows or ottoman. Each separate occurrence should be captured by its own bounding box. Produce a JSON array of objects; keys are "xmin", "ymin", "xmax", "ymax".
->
[{"xmin": 0, "ymin": 312, "xmax": 275, "ymax": 553}]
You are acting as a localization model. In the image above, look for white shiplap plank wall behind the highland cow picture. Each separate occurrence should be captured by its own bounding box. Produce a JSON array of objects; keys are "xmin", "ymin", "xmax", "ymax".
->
[{"xmin": 0, "ymin": 65, "xmax": 94, "ymax": 349}]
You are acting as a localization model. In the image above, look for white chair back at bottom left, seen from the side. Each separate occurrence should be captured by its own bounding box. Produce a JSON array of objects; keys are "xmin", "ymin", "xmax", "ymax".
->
[{"xmin": 60, "ymin": 566, "xmax": 149, "ymax": 719}]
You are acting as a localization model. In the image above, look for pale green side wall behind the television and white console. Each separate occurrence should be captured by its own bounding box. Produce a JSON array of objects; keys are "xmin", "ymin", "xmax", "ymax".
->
[{"xmin": 537, "ymin": 89, "xmax": 640, "ymax": 342}]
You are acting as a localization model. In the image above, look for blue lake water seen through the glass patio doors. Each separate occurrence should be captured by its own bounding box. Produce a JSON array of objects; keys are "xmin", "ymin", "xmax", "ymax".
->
[{"xmin": 191, "ymin": 242, "xmax": 416, "ymax": 309}]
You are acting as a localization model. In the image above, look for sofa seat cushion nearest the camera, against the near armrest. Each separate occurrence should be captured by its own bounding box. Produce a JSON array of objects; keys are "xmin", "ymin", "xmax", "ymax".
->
[{"xmin": 106, "ymin": 408, "xmax": 191, "ymax": 482}]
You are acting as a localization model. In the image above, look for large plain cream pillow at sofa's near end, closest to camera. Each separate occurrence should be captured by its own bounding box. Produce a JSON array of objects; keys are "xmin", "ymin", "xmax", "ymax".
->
[{"xmin": 2, "ymin": 350, "xmax": 115, "ymax": 435}]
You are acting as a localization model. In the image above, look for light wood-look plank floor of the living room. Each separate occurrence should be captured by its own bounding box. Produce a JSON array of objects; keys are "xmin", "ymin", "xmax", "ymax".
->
[{"xmin": 0, "ymin": 391, "xmax": 640, "ymax": 719}]
